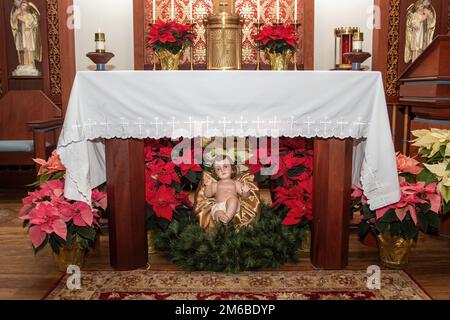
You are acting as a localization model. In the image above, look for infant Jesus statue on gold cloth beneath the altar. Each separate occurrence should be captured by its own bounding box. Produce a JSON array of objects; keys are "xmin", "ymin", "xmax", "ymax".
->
[{"xmin": 194, "ymin": 155, "xmax": 261, "ymax": 230}]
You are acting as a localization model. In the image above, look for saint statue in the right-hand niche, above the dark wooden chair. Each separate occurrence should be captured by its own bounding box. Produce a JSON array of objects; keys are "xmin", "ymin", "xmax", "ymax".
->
[{"xmin": 405, "ymin": 0, "xmax": 436, "ymax": 63}]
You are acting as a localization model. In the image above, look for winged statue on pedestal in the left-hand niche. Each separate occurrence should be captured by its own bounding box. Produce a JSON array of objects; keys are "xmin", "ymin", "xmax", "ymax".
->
[{"xmin": 10, "ymin": 0, "xmax": 42, "ymax": 76}]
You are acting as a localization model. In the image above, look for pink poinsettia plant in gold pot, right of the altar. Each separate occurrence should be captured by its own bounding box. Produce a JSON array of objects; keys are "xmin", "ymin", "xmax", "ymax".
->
[{"xmin": 352, "ymin": 154, "xmax": 442, "ymax": 269}]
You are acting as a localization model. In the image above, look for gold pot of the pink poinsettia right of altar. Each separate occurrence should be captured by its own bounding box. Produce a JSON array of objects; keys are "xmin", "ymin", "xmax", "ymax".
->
[{"xmin": 377, "ymin": 232, "xmax": 414, "ymax": 269}]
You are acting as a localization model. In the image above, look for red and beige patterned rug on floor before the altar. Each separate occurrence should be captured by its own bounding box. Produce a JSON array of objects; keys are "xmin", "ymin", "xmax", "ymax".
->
[{"xmin": 46, "ymin": 270, "xmax": 430, "ymax": 300}]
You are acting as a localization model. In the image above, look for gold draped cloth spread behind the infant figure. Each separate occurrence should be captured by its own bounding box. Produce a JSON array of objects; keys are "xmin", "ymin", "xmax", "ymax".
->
[{"xmin": 194, "ymin": 171, "xmax": 261, "ymax": 231}]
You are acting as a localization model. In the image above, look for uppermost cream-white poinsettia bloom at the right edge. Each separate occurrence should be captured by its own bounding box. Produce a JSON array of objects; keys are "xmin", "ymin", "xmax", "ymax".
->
[{"xmin": 412, "ymin": 128, "xmax": 450, "ymax": 158}]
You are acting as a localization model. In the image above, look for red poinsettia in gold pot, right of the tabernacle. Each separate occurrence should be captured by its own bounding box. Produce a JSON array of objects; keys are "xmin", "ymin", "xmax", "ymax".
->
[{"xmin": 253, "ymin": 25, "xmax": 299, "ymax": 70}]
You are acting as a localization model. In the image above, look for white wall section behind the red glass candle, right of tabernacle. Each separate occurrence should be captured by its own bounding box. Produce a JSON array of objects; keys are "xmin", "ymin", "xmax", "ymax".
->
[{"xmin": 314, "ymin": 0, "xmax": 373, "ymax": 70}]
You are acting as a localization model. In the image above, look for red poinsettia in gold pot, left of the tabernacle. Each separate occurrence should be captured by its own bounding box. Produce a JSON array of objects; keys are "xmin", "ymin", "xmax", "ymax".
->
[{"xmin": 147, "ymin": 20, "xmax": 194, "ymax": 70}]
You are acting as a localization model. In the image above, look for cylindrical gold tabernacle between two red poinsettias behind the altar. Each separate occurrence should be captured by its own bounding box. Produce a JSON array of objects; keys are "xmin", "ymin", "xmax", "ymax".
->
[{"xmin": 205, "ymin": 1, "xmax": 243, "ymax": 70}]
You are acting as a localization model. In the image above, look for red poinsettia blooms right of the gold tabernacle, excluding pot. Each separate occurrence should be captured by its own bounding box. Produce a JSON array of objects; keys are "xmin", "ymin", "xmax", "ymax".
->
[{"xmin": 253, "ymin": 25, "xmax": 299, "ymax": 53}]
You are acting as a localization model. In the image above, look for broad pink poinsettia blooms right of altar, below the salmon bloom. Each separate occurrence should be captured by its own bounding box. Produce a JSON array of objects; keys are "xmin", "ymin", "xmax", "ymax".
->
[{"xmin": 376, "ymin": 181, "xmax": 441, "ymax": 225}]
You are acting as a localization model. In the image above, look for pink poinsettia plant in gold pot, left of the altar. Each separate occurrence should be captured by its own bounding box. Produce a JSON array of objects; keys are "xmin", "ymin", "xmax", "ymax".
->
[{"xmin": 19, "ymin": 152, "xmax": 107, "ymax": 272}]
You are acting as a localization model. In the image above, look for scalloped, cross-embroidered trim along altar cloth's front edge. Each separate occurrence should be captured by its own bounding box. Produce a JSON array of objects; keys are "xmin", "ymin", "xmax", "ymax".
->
[{"xmin": 60, "ymin": 117, "xmax": 370, "ymax": 146}]
